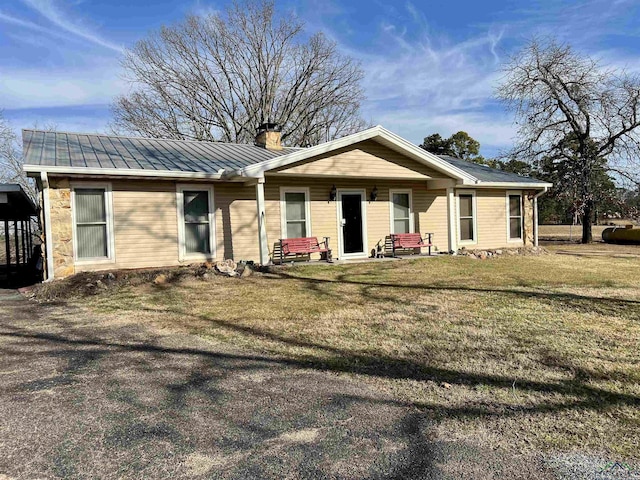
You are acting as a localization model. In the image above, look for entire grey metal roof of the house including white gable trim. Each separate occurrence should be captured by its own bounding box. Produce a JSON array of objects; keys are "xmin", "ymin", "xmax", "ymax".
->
[{"xmin": 22, "ymin": 126, "xmax": 544, "ymax": 185}]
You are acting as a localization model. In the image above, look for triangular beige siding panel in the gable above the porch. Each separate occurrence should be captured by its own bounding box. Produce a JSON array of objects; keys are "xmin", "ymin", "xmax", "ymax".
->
[{"xmin": 278, "ymin": 140, "xmax": 444, "ymax": 180}]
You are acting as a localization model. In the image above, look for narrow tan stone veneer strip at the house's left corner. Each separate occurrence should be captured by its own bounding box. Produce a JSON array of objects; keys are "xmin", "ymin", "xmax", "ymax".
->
[{"xmin": 49, "ymin": 179, "xmax": 75, "ymax": 278}]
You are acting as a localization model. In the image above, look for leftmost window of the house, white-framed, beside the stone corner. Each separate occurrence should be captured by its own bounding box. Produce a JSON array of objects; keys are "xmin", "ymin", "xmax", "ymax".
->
[{"xmin": 73, "ymin": 185, "xmax": 113, "ymax": 262}]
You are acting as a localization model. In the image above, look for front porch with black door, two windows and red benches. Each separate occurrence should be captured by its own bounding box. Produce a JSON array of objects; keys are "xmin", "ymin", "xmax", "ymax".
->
[{"xmin": 256, "ymin": 176, "xmax": 453, "ymax": 265}]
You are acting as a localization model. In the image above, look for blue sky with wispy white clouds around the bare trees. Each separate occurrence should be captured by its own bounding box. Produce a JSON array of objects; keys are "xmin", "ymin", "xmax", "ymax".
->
[{"xmin": 0, "ymin": 0, "xmax": 640, "ymax": 156}]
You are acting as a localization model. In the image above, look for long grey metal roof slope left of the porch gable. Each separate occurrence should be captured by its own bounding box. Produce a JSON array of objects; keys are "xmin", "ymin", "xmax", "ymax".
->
[{"xmin": 22, "ymin": 130, "xmax": 298, "ymax": 173}]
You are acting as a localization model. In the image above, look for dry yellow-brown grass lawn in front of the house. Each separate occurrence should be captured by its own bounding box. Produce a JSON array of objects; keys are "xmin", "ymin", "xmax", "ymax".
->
[{"xmin": 51, "ymin": 251, "xmax": 640, "ymax": 459}]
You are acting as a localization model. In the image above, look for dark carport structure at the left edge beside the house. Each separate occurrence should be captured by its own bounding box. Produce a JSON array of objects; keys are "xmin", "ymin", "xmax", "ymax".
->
[{"xmin": 0, "ymin": 183, "xmax": 38, "ymax": 287}]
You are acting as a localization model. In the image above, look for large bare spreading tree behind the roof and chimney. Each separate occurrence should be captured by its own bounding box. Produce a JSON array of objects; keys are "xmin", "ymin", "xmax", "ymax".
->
[{"xmin": 112, "ymin": 0, "xmax": 364, "ymax": 146}]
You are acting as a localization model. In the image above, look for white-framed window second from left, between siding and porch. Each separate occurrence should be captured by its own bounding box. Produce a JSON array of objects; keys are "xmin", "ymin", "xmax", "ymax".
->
[{"xmin": 178, "ymin": 186, "xmax": 214, "ymax": 260}]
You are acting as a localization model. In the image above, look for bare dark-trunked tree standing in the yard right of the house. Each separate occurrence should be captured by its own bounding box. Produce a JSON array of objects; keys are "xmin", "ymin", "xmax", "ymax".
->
[{"xmin": 498, "ymin": 36, "xmax": 640, "ymax": 243}]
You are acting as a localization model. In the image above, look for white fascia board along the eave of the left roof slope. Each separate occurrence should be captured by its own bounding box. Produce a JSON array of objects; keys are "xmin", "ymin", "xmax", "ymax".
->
[{"xmin": 23, "ymin": 165, "xmax": 225, "ymax": 180}]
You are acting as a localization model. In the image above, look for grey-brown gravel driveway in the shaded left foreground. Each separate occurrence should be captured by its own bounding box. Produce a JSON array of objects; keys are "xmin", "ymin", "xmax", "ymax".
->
[{"xmin": 0, "ymin": 291, "xmax": 632, "ymax": 479}]
